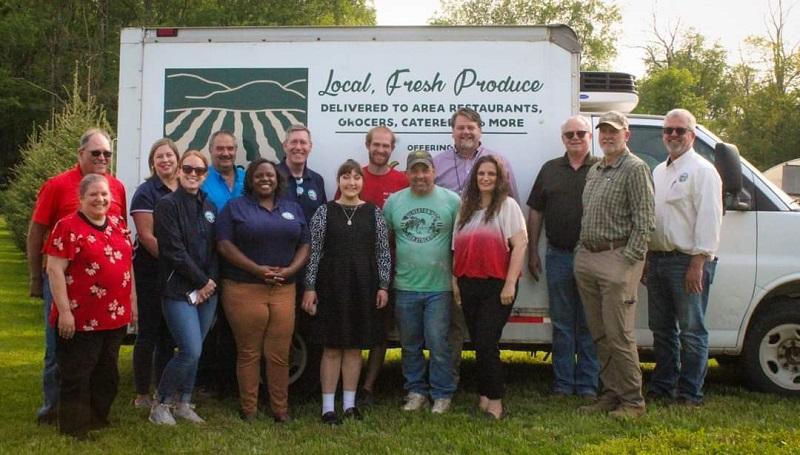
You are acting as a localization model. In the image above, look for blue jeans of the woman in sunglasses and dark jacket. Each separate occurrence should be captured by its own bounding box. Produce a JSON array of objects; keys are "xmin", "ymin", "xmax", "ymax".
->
[{"xmin": 158, "ymin": 294, "xmax": 217, "ymax": 403}]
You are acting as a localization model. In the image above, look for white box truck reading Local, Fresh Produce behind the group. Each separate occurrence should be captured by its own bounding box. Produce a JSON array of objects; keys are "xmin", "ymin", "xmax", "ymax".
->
[{"xmin": 117, "ymin": 26, "xmax": 800, "ymax": 395}]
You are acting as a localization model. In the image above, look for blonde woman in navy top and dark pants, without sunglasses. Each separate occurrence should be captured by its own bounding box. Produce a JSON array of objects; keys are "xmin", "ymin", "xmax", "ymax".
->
[{"xmin": 131, "ymin": 137, "xmax": 180, "ymax": 409}]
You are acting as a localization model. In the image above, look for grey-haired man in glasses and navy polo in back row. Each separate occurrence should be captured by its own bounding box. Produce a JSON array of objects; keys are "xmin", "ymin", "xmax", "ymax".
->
[{"xmin": 278, "ymin": 125, "xmax": 328, "ymax": 224}]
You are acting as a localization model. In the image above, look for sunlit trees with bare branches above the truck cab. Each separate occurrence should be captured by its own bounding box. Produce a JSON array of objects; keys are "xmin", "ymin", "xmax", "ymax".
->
[{"xmin": 636, "ymin": 0, "xmax": 800, "ymax": 169}]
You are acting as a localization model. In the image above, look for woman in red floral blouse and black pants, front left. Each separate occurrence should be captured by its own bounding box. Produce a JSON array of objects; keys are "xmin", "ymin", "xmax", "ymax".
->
[{"xmin": 45, "ymin": 174, "xmax": 136, "ymax": 439}]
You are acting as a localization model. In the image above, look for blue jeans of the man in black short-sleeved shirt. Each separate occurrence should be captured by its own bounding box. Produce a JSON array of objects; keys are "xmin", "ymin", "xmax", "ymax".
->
[{"xmin": 545, "ymin": 246, "xmax": 600, "ymax": 395}]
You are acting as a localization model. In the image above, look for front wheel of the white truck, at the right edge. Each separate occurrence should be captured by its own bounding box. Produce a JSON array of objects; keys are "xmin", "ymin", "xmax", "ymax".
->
[{"xmin": 743, "ymin": 299, "xmax": 800, "ymax": 396}]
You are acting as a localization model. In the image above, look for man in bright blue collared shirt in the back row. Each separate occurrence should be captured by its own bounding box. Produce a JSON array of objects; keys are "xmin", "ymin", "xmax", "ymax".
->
[{"xmin": 197, "ymin": 130, "xmax": 244, "ymax": 395}]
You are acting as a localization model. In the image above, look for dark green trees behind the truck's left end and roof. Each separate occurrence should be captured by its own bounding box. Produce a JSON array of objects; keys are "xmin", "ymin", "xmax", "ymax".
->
[{"xmin": 0, "ymin": 0, "xmax": 375, "ymax": 186}]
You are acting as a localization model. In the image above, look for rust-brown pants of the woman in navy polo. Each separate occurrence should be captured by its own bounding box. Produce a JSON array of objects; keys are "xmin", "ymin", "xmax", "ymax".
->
[{"xmin": 222, "ymin": 280, "xmax": 295, "ymax": 416}]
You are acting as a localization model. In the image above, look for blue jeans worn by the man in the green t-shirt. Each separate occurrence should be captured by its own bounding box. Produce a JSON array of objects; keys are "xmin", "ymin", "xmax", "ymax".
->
[{"xmin": 394, "ymin": 290, "xmax": 456, "ymax": 400}]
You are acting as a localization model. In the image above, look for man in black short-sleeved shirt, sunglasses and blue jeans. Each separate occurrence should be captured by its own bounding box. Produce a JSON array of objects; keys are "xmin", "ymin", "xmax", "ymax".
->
[{"xmin": 528, "ymin": 115, "xmax": 599, "ymax": 399}]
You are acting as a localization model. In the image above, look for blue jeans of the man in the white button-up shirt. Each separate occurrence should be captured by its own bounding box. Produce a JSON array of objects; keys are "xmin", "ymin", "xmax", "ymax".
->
[{"xmin": 647, "ymin": 254, "xmax": 717, "ymax": 401}]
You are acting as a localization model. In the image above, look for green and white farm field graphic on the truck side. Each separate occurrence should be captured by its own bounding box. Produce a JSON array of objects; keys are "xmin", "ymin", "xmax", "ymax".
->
[{"xmin": 164, "ymin": 68, "xmax": 308, "ymax": 164}]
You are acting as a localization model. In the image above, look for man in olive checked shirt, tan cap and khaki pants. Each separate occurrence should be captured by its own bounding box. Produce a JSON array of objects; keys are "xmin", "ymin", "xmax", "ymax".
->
[{"xmin": 575, "ymin": 111, "xmax": 655, "ymax": 418}]
